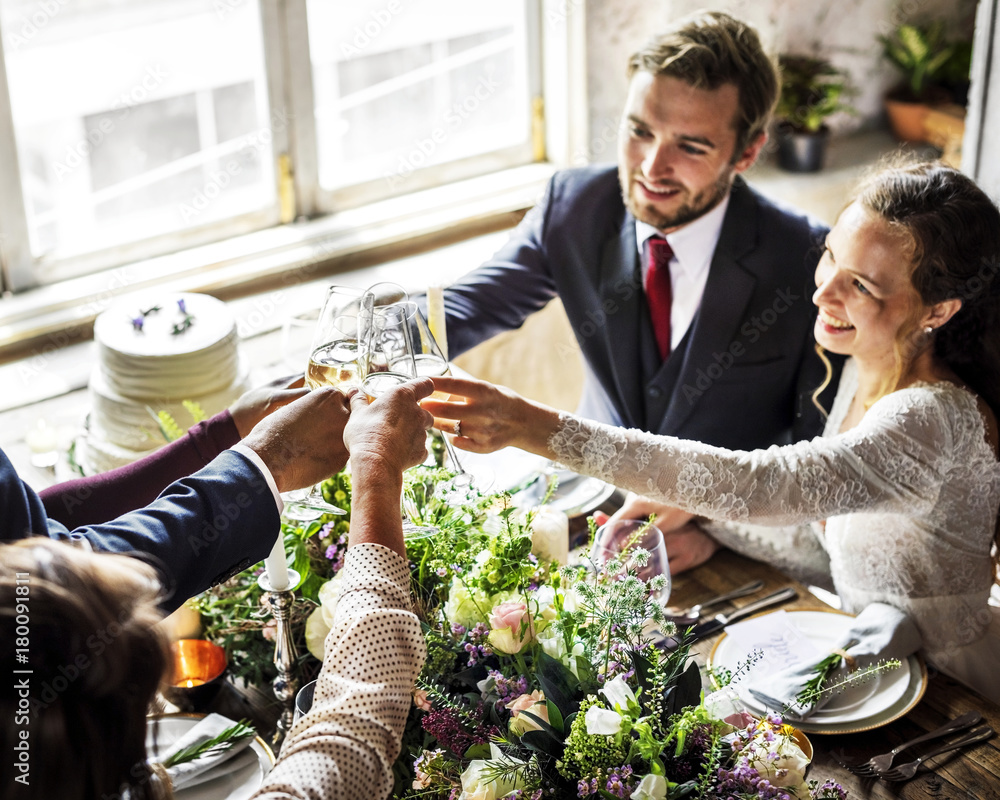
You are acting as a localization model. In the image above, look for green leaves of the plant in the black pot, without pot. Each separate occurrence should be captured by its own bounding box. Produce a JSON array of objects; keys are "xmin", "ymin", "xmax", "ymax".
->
[{"xmin": 775, "ymin": 55, "xmax": 855, "ymax": 133}]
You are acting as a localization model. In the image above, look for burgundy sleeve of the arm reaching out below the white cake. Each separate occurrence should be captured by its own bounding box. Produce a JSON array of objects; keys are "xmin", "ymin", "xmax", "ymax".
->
[{"xmin": 39, "ymin": 410, "xmax": 240, "ymax": 530}]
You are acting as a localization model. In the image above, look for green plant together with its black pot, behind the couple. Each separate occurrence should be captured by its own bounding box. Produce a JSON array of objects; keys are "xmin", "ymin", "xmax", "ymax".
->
[{"xmin": 775, "ymin": 54, "xmax": 854, "ymax": 172}]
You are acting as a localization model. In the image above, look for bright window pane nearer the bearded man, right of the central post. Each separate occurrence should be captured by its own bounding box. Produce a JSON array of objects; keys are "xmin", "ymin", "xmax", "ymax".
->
[{"xmin": 307, "ymin": 0, "xmax": 531, "ymax": 191}]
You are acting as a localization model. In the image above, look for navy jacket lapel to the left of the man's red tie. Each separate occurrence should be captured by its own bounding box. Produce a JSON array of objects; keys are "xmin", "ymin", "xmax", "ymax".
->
[{"xmin": 598, "ymin": 213, "xmax": 643, "ymax": 427}]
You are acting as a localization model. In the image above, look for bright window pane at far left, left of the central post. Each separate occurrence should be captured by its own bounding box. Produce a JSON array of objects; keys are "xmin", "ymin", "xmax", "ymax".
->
[{"xmin": 0, "ymin": 0, "xmax": 276, "ymax": 257}]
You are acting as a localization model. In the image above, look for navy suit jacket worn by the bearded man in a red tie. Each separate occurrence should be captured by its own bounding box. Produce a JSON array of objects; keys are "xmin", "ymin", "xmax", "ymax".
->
[{"xmin": 445, "ymin": 166, "xmax": 835, "ymax": 449}]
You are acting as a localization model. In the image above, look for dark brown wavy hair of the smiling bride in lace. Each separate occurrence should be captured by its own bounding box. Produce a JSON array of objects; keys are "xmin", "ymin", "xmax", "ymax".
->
[{"xmin": 857, "ymin": 162, "xmax": 1000, "ymax": 414}]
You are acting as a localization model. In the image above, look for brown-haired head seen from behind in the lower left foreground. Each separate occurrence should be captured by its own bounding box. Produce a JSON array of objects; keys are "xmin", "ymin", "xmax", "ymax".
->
[{"xmin": 0, "ymin": 537, "xmax": 168, "ymax": 800}]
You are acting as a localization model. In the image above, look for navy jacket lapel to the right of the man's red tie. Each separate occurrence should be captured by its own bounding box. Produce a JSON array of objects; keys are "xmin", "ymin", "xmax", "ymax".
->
[{"xmin": 650, "ymin": 177, "xmax": 757, "ymax": 434}]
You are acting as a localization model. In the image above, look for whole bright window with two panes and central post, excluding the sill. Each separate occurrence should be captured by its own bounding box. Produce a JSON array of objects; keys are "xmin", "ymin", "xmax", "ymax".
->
[{"xmin": 0, "ymin": 0, "xmax": 540, "ymax": 289}]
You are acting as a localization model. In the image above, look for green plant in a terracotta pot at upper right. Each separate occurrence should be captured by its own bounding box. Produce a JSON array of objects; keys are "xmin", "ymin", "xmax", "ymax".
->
[{"xmin": 879, "ymin": 20, "xmax": 964, "ymax": 142}]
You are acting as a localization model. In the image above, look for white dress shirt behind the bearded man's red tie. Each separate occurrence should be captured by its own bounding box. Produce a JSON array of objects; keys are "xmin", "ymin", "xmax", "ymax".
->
[{"xmin": 635, "ymin": 194, "xmax": 729, "ymax": 351}]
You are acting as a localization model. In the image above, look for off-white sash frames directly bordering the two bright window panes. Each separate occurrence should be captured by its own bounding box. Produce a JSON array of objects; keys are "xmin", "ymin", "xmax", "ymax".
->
[{"xmin": 0, "ymin": 0, "xmax": 552, "ymax": 294}]
